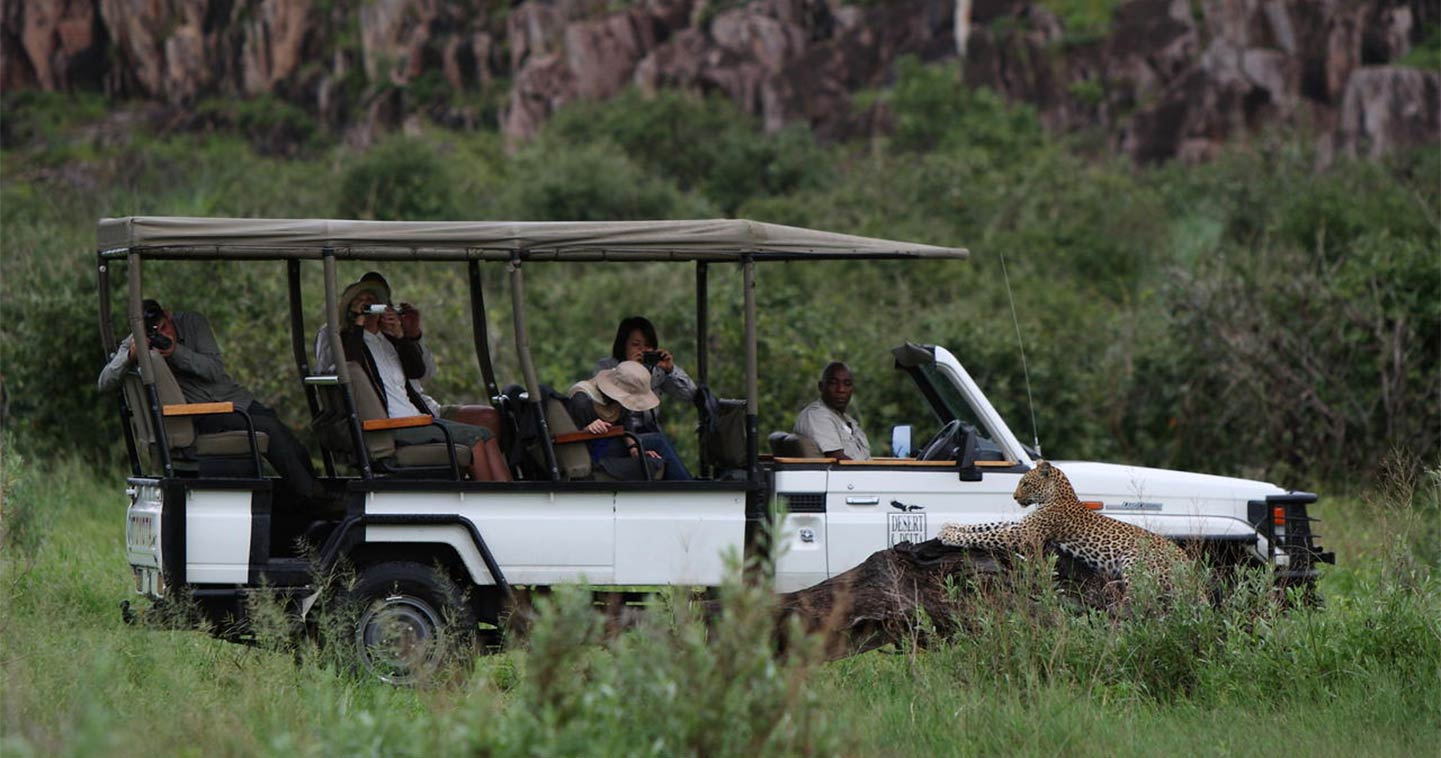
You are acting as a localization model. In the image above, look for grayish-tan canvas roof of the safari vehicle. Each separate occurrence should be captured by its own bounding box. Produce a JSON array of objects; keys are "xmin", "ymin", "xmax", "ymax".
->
[{"xmin": 97, "ymin": 216, "xmax": 967, "ymax": 262}]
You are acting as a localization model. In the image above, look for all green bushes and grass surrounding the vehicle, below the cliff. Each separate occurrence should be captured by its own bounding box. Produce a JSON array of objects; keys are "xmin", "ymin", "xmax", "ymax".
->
[{"xmin": 0, "ymin": 56, "xmax": 1441, "ymax": 755}]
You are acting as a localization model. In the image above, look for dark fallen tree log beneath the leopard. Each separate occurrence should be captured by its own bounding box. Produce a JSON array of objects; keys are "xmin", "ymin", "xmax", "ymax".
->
[{"xmin": 778, "ymin": 539, "xmax": 1117, "ymax": 660}]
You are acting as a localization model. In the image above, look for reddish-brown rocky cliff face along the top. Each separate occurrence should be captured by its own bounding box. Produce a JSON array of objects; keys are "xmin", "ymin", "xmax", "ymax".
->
[{"xmin": 0, "ymin": 0, "xmax": 1441, "ymax": 161}]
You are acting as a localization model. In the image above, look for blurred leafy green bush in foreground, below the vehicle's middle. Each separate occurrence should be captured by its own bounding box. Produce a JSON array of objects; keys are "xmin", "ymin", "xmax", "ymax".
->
[{"xmin": 493, "ymin": 585, "xmax": 840, "ymax": 755}]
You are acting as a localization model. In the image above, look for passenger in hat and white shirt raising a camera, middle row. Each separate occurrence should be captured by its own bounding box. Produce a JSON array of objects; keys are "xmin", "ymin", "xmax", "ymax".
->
[{"xmin": 316, "ymin": 274, "xmax": 510, "ymax": 481}]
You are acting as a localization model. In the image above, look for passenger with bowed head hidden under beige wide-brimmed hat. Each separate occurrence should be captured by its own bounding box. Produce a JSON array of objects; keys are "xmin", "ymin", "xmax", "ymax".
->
[{"xmin": 566, "ymin": 360, "xmax": 692, "ymax": 481}]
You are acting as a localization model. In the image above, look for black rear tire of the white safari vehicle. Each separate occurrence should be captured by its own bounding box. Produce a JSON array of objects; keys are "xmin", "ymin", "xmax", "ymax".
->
[{"xmin": 346, "ymin": 561, "xmax": 476, "ymax": 685}]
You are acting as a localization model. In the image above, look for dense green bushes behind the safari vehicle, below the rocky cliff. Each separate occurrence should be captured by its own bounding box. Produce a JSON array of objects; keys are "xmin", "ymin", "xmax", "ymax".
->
[{"xmin": 0, "ymin": 61, "xmax": 1441, "ymax": 487}]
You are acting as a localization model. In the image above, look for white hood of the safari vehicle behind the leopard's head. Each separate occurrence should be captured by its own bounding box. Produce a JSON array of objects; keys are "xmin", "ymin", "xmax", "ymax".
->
[{"xmin": 1052, "ymin": 461, "xmax": 1285, "ymax": 504}]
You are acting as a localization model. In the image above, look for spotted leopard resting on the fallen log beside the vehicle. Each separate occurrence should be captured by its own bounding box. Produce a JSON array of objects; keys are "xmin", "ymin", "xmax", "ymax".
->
[{"xmin": 937, "ymin": 460, "xmax": 1189, "ymax": 591}]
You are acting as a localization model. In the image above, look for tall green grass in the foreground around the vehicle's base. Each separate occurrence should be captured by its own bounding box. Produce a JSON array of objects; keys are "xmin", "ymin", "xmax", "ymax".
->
[{"xmin": 0, "ymin": 444, "xmax": 1441, "ymax": 755}]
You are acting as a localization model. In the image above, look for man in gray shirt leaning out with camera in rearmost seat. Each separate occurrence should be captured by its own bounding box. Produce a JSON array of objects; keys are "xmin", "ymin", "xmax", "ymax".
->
[{"xmin": 99, "ymin": 300, "xmax": 326, "ymax": 500}]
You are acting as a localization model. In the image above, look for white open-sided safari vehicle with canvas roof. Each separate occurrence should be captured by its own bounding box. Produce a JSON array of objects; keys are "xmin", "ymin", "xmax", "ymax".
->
[{"xmin": 97, "ymin": 218, "xmax": 1331, "ymax": 679}]
